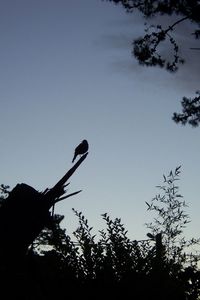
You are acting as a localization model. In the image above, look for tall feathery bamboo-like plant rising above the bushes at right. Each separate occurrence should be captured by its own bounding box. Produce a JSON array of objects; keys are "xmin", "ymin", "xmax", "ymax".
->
[{"xmin": 146, "ymin": 166, "xmax": 200, "ymax": 267}]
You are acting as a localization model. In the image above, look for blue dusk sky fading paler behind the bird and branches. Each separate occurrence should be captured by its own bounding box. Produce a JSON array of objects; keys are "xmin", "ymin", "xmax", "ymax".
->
[{"xmin": 0, "ymin": 0, "xmax": 200, "ymax": 243}]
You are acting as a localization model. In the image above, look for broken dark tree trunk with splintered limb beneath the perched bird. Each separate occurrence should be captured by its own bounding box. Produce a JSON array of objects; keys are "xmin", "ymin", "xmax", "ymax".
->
[{"xmin": 0, "ymin": 153, "xmax": 88, "ymax": 264}]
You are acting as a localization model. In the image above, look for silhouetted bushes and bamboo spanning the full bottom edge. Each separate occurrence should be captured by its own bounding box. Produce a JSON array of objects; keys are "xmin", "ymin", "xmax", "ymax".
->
[{"xmin": 0, "ymin": 167, "xmax": 200, "ymax": 300}]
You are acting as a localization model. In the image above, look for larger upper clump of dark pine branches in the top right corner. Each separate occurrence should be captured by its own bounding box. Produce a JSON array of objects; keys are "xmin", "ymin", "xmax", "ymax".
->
[{"xmin": 104, "ymin": 0, "xmax": 200, "ymax": 72}]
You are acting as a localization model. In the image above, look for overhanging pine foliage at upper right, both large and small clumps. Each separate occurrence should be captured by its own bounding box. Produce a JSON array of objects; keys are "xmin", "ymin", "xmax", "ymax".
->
[{"xmin": 103, "ymin": 0, "xmax": 200, "ymax": 127}]
